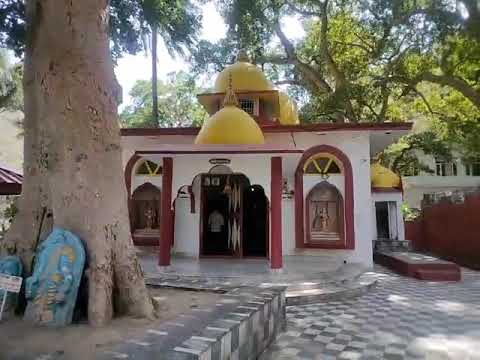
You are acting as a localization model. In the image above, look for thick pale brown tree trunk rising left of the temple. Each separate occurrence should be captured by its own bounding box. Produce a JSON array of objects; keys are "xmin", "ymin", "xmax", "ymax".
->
[{"xmin": 7, "ymin": 0, "xmax": 153, "ymax": 325}]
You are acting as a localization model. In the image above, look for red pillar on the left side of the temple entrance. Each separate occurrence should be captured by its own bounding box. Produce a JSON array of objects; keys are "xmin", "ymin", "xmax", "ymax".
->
[{"xmin": 158, "ymin": 157, "xmax": 173, "ymax": 266}]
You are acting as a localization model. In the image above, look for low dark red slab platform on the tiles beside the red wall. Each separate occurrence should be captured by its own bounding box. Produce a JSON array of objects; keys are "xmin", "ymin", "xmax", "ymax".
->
[{"xmin": 373, "ymin": 251, "xmax": 462, "ymax": 281}]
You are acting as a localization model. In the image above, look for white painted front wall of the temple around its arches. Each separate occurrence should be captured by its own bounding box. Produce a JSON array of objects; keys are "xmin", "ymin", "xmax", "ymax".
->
[{"xmin": 123, "ymin": 131, "xmax": 376, "ymax": 266}]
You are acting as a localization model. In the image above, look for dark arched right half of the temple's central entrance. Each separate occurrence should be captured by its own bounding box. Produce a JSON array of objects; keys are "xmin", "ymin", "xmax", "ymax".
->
[{"xmin": 242, "ymin": 185, "xmax": 268, "ymax": 257}]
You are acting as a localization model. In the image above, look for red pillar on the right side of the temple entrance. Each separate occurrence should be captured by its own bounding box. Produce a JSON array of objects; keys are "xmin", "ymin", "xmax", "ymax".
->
[{"xmin": 270, "ymin": 157, "xmax": 283, "ymax": 270}]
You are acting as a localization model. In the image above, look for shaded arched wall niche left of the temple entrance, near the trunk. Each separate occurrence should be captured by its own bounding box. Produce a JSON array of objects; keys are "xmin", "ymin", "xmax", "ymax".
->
[{"xmin": 131, "ymin": 183, "xmax": 162, "ymax": 238}]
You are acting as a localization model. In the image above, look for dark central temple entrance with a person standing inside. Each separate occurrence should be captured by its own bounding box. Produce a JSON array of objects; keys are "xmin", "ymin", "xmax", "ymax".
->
[{"xmin": 200, "ymin": 173, "xmax": 268, "ymax": 257}]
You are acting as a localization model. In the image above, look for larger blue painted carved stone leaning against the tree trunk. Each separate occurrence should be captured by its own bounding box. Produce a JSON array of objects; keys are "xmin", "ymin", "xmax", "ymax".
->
[{"xmin": 25, "ymin": 228, "xmax": 85, "ymax": 326}]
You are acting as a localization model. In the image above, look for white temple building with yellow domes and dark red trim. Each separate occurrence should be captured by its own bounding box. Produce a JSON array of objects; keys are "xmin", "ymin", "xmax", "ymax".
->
[{"xmin": 122, "ymin": 56, "xmax": 411, "ymax": 270}]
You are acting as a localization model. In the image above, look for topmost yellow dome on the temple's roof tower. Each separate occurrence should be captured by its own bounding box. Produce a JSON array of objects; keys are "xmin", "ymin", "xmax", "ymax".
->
[{"xmin": 215, "ymin": 61, "xmax": 273, "ymax": 92}]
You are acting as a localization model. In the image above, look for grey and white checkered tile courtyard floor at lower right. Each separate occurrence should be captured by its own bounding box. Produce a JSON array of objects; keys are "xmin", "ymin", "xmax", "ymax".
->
[{"xmin": 261, "ymin": 267, "xmax": 480, "ymax": 360}]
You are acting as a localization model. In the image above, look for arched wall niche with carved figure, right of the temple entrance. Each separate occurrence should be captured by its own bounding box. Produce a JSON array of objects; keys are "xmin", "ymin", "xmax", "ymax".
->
[{"xmin": 306, "ymin": 181, "xmax": 344, "ymax": 244}]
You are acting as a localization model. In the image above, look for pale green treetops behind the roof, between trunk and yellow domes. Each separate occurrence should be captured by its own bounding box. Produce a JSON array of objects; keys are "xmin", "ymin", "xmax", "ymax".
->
[{"xmin": 120, "ymin": 72, "xmax": 208, "ymax": 128}]
